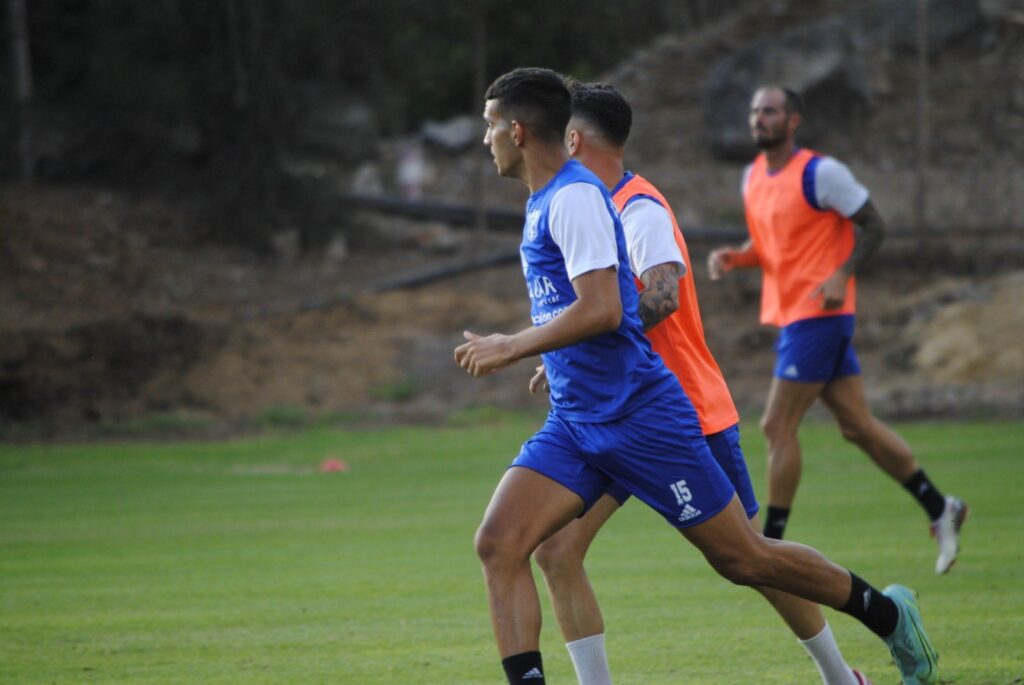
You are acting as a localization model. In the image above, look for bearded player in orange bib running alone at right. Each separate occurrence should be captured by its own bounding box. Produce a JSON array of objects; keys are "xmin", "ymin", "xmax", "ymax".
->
[{"xmin": 708, "ymin": 86, "xmax": 968, "ymax": 573}]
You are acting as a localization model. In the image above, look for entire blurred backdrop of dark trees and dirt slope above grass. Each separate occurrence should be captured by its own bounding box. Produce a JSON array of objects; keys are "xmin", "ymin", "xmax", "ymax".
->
[{"xmin": 0, "ymin": 0, "xmax": 1024, "ymax": 437}]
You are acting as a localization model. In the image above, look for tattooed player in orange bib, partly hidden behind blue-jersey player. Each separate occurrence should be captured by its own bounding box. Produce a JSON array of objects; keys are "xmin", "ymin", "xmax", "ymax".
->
[{"xmin": 531, "ymin": 83, "xmax": 869, "ymax": 685}]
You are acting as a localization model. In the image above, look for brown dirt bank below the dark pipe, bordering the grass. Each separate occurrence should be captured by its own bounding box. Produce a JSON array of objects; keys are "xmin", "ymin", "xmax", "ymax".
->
[{"xmin": 0, "ymin": 183, "xmax": 1024, "ymax": 428}]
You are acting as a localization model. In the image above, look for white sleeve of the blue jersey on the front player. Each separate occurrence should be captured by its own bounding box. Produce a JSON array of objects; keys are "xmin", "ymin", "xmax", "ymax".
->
[{"xmin": 548, "ymin": 183, "xmax": 618, "ymax": 281}]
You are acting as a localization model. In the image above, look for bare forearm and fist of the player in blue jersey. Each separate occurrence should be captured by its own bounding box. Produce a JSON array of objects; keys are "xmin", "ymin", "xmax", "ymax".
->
[{"xmin": 455, "ymin": 266, "xmax": 623, "ymax": 377}]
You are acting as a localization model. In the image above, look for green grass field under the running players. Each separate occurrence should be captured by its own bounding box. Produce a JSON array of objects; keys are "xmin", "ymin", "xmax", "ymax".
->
[{"xmin": 0, "ymin": 417, "xmax": 1024, "ymax": 685}]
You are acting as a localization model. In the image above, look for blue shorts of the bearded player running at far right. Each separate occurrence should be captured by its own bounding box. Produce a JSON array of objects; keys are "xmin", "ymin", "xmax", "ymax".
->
[{"xmin": 775, "ymin": 314, "xmax": 860, "ymax": 383}]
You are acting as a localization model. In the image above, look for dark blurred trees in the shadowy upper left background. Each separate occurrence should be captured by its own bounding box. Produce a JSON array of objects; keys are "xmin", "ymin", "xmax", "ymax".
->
[{"xmin": 0, "ymin": 0, "xmax": 743, "ymax": 248}]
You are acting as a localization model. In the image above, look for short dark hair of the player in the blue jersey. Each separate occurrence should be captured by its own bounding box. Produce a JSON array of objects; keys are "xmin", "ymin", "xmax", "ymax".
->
[{"xmin": 484, "ymin": 67, "xmax": 571, "ymax": 142}]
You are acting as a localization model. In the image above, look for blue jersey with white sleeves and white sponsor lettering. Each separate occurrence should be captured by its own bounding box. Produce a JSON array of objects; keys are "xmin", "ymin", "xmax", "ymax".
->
[{"xmin": 519, "ymin": 161, "xmax": 679, "ymax": 423}]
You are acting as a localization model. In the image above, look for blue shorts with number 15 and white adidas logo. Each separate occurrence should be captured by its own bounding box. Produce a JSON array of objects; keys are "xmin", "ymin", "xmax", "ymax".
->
[{"xmin": 512, "ymin": 386, "xmax": 735, "ymax": 528}]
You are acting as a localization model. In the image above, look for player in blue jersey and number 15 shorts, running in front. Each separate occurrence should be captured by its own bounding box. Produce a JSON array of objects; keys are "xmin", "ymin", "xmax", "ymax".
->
[{"xmin": 455, "ymin": 69, "xmax": 938, "ymax": 685}]
